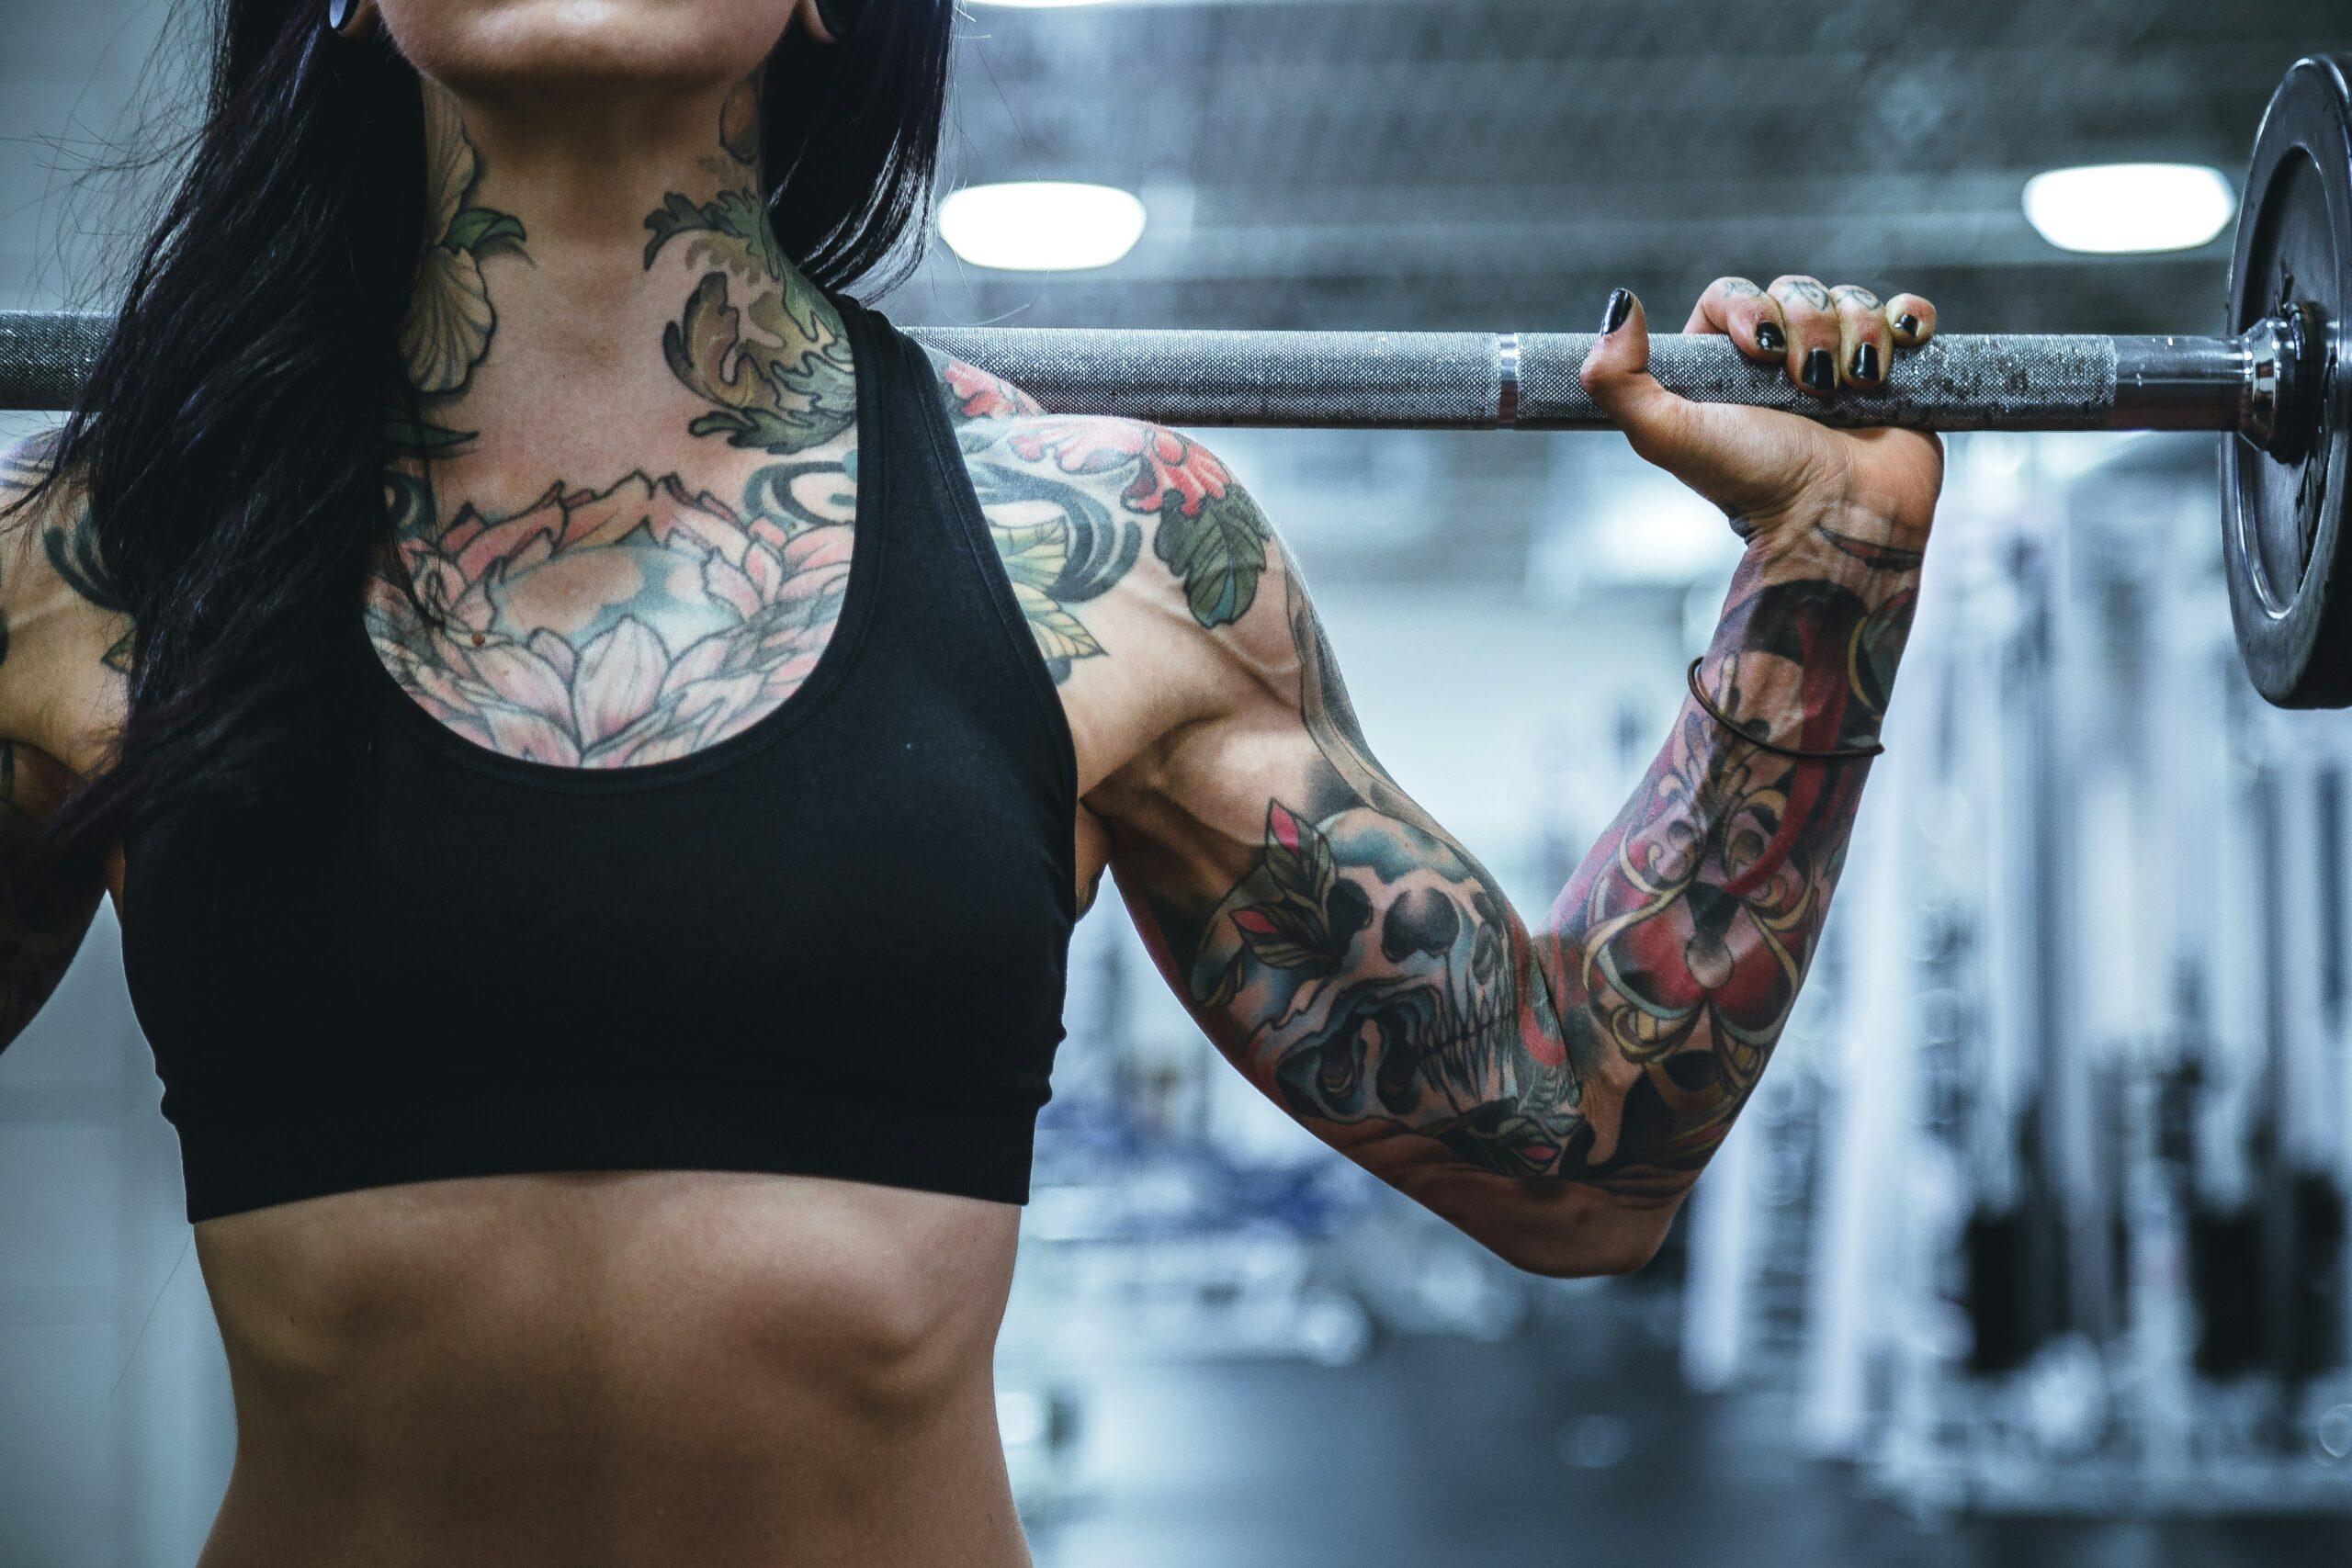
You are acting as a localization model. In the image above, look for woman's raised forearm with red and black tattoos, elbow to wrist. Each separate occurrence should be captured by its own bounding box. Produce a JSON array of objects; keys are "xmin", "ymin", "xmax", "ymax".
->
[{"xmin": 1532, "ymin": 510, "xmax": 1919, "ymax": 1201}]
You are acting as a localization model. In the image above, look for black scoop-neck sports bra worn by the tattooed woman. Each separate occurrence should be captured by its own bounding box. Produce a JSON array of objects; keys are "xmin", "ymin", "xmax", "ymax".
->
[{"xmin": 122, "ymin": 301, "xmax": 1077, "ymax": 1220}]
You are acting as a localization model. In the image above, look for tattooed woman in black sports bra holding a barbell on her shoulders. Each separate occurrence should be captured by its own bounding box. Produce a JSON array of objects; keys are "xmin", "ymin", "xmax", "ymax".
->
[{"xmin": 0, "ymin": 0, "xmax": 1940, "ymax": 1568}]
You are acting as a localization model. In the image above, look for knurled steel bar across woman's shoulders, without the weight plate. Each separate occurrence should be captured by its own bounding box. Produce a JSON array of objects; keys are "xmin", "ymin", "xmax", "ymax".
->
[{"xmin": 0, "ymin": 310, "xmax": 2279, "ymax": 430}]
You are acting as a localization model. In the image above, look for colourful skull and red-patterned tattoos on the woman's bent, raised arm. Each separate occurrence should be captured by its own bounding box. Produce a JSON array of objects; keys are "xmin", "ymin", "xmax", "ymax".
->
[{"xmin": 1155, "ymin": 522, "xmax": 1919, "ymax": 1199}]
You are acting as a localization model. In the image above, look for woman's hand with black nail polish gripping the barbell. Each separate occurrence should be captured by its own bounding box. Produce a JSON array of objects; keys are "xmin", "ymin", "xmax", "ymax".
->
[{"xmin": 1583, "ymin": 277, "xmax": 1943, "ymax": 550}]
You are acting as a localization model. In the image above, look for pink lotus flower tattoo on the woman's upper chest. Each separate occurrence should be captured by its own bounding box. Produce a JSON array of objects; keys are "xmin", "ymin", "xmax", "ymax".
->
[{"xmin": 369, "ymin": 472, "xmax": 852, "ymax": 766}]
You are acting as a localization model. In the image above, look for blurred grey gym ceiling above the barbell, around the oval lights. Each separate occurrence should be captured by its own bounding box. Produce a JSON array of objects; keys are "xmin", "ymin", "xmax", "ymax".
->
[{"xmin": 894, "ymin": 0, "xmax": 2352, "ymax": 332}]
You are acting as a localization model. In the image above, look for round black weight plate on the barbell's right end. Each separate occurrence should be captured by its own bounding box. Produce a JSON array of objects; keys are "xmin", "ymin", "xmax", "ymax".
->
[{"xmin": 2222, "ymin": 54, "xmax": 2352, "ymax": 707}]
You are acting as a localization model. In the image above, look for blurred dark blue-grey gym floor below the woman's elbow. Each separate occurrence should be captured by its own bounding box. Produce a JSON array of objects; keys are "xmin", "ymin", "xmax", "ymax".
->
[{"xmin": 1033, "ymin": 1288, "xmax": 2352, "ymax": 1568}]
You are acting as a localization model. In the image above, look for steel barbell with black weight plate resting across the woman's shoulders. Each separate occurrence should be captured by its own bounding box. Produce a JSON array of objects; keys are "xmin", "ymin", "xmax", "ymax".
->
[{"xmin": 0, "ymin": 54, "xmax": 2352, "ymax": 707}]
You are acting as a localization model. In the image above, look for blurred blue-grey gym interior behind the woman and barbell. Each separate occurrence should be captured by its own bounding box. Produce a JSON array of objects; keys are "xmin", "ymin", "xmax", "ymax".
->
[{"xmin": 0, "ymin": 0, "xmax": 2352, "ymax": 1568}]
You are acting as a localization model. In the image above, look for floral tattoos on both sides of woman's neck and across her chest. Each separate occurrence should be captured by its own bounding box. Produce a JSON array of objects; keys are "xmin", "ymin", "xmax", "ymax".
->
[{"xmin": 367, "ymin": 83, "xmax": 856, "ymax": 769}]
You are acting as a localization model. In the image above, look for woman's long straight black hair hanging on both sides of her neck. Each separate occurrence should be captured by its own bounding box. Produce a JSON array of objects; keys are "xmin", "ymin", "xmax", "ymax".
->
[{"xmin": 26, "ymin": 0, "xmax": 953, "ymax": 879}]
